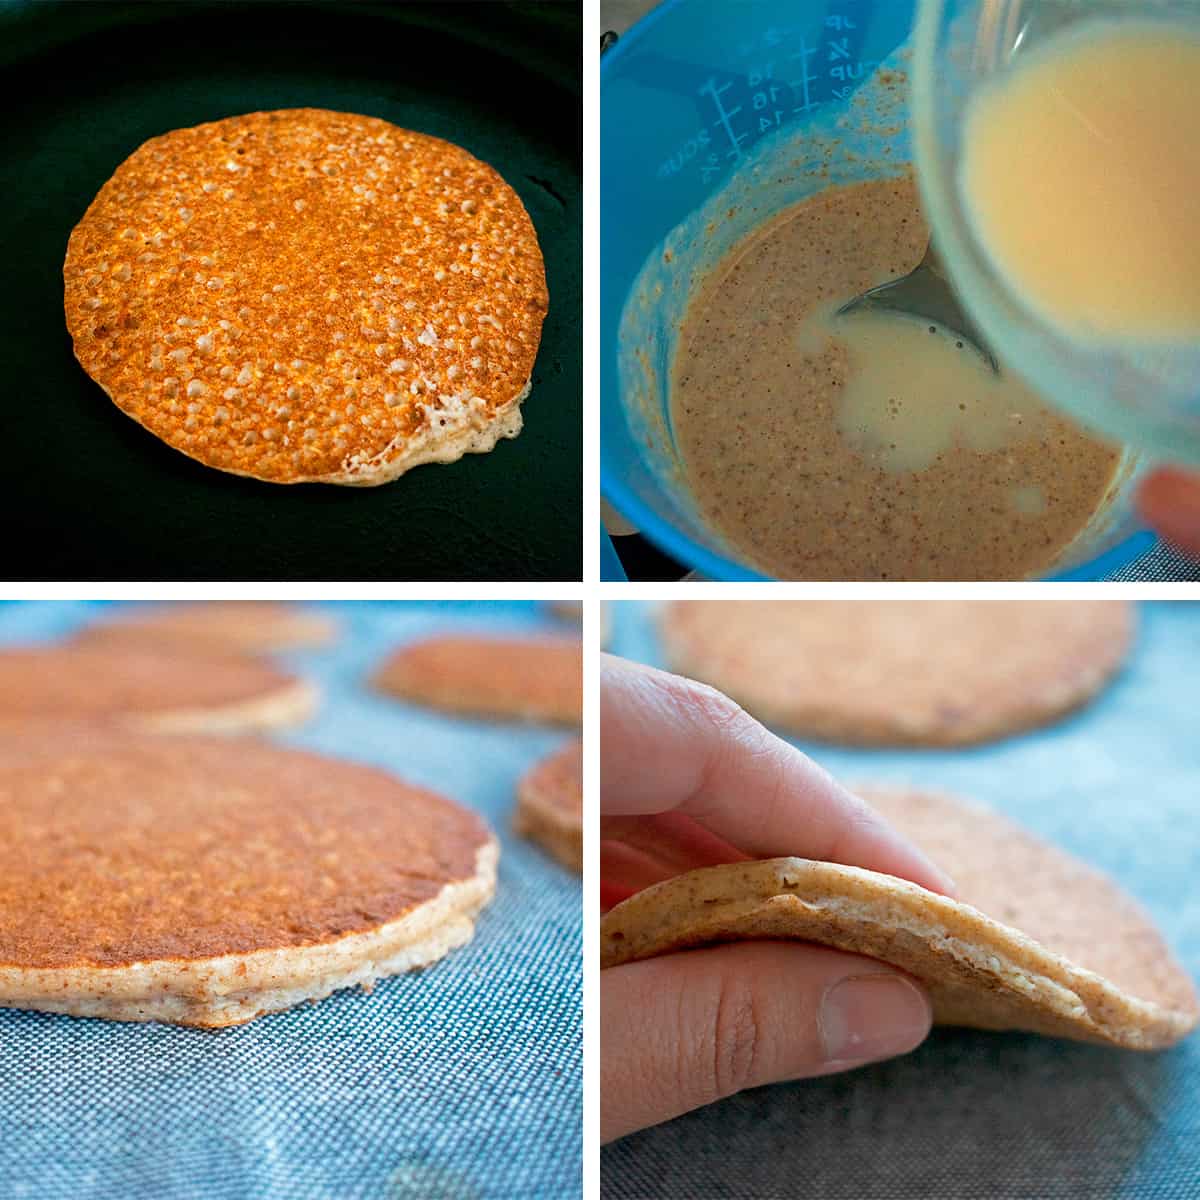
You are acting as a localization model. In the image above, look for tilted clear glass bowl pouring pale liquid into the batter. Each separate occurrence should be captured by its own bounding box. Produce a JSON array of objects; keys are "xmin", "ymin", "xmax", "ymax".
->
[{"xmin": 912, "ymin": 0, "xmax": 1200, "ymax": 464}]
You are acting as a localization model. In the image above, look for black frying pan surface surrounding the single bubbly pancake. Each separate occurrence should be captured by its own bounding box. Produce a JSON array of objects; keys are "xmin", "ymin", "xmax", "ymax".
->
[{"xmin": 0, "ymin": 0, "xmax": 582, "ymax": 581}]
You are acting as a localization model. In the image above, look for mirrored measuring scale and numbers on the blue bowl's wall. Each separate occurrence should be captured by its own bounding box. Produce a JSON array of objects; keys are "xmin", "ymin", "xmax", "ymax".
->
[{"xmin": 655, "ymin": 13, "xmax": 878, "ymax": 184}]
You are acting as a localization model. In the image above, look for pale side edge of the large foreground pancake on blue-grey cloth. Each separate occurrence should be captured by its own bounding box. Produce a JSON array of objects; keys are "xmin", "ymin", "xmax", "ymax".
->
[{"xmin": 0, "ymin": 836, "xmax": 499, "ymax": 1030}]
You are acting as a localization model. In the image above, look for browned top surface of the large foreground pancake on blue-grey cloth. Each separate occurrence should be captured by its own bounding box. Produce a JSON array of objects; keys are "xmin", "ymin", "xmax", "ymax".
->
[{"xmin": 0, "ymin": 722, "xmax": 491, "ymax": 968}]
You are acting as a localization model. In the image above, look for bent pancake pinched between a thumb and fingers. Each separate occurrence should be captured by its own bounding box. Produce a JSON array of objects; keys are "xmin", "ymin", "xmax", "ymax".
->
[{"xmin": 600, "ymin": 787, "xmax": 1200, "ymax": 1050}]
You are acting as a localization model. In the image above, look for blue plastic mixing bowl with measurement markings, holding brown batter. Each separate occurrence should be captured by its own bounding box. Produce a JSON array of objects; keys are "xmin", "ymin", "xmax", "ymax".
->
[{"xmin": 600, "ymin": 0, "xmax": 1153, "ymax": 580}]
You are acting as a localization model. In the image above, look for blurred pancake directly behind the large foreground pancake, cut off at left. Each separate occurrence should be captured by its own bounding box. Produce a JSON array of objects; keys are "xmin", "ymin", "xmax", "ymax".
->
[{"xmin": 0, "ymin": 643, "xmax": 317, "ymax": 733}]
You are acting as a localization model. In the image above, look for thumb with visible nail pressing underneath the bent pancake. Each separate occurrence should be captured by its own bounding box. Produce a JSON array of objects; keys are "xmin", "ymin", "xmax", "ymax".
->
[{"xmin": 600, "ymin": 942, "xmax": 931, "ymax": 1141}]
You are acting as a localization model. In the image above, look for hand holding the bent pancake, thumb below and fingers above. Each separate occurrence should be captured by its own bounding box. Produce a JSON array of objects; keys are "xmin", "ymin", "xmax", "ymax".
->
[{"xmin": 600, "ymin": 655, "xmax": 953, "ymax": 1141}]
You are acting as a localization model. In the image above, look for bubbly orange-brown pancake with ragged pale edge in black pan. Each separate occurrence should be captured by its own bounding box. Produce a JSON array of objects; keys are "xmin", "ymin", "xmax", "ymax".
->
[{"xmin": 64, "ymin": 108, "xmax": 547, "ymax": 485}]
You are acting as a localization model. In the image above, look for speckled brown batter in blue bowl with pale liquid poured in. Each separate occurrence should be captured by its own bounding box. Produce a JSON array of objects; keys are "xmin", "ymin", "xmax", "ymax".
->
[{"xmin": 671, "ymin": 176, "xmax": 1121, "ymax": 580}]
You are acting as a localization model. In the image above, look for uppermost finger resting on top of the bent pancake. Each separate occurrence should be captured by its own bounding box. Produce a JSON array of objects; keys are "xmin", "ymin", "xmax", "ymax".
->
[{"xmin": 600, "ymin": 655, "xmax": 954, "ymax": 893}]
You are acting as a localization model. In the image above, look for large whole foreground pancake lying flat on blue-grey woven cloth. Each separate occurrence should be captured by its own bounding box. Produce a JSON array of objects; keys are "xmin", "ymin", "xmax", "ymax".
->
[{"xmin": 0, "ymin": 722, "xmax": 497, "ymax": 1028}]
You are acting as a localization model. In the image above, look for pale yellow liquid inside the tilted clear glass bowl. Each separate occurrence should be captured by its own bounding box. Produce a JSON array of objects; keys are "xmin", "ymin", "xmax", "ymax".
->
[{"xmin": 961, "ymin": 20, "xmax": 1200, "ymax": 342}]
